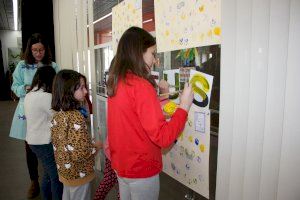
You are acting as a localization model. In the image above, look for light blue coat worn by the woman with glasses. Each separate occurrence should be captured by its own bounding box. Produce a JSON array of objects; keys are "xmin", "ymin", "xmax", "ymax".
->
[{"xmin": 9, "ymin": 60, "xmax": 59, "ymax": 140}]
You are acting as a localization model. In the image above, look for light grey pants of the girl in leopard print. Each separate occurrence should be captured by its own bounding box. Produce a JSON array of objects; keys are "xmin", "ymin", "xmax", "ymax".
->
[{"xmin": 62, "ymin": 182, "xmax": 91, "ymax": 200}]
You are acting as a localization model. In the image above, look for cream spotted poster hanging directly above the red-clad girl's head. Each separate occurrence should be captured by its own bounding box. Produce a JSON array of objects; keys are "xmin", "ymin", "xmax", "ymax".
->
[{"xmin": 112, "ymin": 0, "xmax": 143, "ymax": 54}]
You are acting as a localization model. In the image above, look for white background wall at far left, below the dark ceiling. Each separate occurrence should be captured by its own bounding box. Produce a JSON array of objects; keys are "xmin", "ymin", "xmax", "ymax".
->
[{"xmin": 0, "ymin": 30, "xmax": 22, "ymax": 72}]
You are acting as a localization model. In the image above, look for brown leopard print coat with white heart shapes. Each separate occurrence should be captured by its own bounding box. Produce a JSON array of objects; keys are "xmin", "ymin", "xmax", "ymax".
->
[{"xmin": 51, "ymin": 110, "xmax": 96, "ymax": 186}]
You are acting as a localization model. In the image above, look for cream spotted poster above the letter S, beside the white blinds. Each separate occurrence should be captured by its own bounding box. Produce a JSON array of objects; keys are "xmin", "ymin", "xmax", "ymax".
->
[{"xmin": 154, "ymin": 0, "xmax": 221, "ymax": 52}]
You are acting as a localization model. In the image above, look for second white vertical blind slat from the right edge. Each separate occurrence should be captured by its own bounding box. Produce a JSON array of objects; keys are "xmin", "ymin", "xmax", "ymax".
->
[{"xmin": 259, "ymin": 0, "xmax": 290, "ymax": 199}]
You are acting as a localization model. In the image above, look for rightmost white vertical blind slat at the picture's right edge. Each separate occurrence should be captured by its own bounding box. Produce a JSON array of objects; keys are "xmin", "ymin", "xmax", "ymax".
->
[{"xmin": 277, "ymin": 0, "xmax": 300, "ymax": 200}]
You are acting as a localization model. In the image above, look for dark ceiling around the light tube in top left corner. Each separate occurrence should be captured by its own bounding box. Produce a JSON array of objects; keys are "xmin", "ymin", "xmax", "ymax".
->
[{"xmin": 0, "ymin": 0, "xmax": 21, "ymax": 30}]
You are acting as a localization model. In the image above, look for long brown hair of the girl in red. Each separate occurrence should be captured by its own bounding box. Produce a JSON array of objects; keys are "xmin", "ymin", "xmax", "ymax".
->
[{"xmin": 107, "ymin": 27, "xmax": 156, "ymax": 96}]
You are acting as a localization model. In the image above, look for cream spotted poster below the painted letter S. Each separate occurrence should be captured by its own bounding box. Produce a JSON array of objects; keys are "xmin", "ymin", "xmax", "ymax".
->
[{"xmin": 163, "ymin": 104, "xmax": 210, "ymax": 198}]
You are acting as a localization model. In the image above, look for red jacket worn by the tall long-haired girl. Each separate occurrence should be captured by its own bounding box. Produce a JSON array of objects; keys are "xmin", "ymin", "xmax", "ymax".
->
[{"xmin": 107, "ymin": 73, "xmax": 187, "ymax": 178}]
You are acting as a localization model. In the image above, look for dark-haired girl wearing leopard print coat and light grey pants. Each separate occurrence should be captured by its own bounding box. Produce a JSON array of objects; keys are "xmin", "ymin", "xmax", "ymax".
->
[{"xmin": 51, "ymin": 70, "xmax": 102, "ymax": 200}]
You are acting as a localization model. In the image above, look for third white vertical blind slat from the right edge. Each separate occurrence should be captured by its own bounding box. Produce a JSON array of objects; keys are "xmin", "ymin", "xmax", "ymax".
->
[{"xmin": 242, "ymin": 0, "xmax": 270, "ymax": 200}]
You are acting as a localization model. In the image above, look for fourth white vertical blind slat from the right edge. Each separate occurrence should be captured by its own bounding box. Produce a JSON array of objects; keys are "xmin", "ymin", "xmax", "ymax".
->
[{"xmin": 229, "ymin": 0, "xmax": 252, "ymax": 199}]
